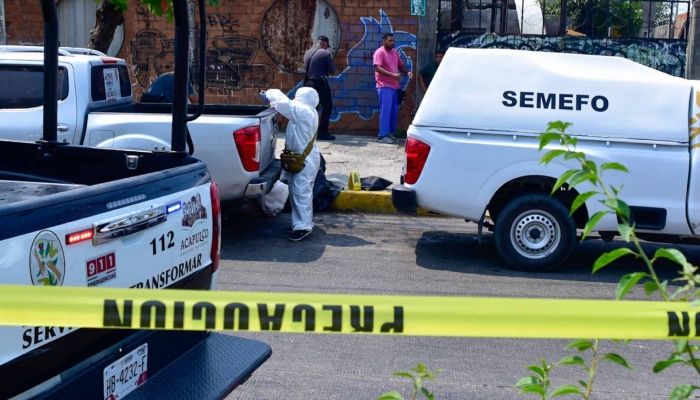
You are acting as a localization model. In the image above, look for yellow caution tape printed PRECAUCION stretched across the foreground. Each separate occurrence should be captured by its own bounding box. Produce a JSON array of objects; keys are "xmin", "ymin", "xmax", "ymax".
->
[{"xmin": 0, "ymin": 286, "xmax": 700, "ymax": 339}]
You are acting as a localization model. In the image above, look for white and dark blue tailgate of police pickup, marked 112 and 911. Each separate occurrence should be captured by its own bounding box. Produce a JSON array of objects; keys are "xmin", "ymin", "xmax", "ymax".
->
[{"xmin": 0, "ymin": 163, "xmax": 213, "ymax": 398}]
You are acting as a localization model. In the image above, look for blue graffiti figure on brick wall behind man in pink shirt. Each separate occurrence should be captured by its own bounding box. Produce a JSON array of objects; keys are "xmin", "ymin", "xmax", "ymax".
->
[{"xmin": 290, "ymin": 9, "xmax": 416, "ymax": 122}]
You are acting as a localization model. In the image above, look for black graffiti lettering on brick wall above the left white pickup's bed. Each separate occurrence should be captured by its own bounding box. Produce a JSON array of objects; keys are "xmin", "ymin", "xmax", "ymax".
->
[{"xmin": 131, "ymin": 10, "xmax": 274, "ymax": 91}]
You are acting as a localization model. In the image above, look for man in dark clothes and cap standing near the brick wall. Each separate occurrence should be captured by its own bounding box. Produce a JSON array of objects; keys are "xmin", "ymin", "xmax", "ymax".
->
[{"xmin": 304, "ymin": 36, "xmax": 335, "ymax": 140}]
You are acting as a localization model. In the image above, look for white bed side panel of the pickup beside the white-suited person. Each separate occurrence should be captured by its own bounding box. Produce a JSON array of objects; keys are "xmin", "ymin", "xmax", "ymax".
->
[{"xmin": 85, "ymin": 104, "xmax": 277, "ymax": 201}]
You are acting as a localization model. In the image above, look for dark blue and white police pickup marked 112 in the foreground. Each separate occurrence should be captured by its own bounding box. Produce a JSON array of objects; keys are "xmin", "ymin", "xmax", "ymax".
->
[{"xmin": 0, "ymin": 0, "xmax": 270, "ymax": 400}]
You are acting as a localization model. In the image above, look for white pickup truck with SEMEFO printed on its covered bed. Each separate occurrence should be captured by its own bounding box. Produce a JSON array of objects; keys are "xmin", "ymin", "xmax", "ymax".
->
[{"xmin": 392, "ymin": 48, "xmax": 700, "ymax": 271}]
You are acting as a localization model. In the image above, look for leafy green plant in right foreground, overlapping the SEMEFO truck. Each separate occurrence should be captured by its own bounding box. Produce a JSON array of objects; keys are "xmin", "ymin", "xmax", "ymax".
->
[{"xmin": 516, "ymin": 120, "xmax": 700, "ymax": 400}]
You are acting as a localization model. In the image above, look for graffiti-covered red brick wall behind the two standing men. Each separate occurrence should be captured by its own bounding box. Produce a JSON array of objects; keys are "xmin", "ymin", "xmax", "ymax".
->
[{"xmin": 5, "ymin": 0, "xmax": 418, "ymax": 134}]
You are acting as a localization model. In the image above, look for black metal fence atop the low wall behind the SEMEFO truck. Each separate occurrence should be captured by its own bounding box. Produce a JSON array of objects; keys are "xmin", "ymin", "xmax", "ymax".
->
[{"xmin": 438, "ymin": 0, "xmax": 690, "ymax": 39}]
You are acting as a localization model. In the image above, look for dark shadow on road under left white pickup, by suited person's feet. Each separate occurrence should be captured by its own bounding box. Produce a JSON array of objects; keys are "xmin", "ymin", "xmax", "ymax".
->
[{"xmin": 221, "ymin": 213, "xmax": 373, "ymax": 263}]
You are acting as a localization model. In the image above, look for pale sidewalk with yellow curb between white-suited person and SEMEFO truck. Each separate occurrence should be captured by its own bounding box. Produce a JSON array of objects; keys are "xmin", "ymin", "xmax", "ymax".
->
[{"xmin": 275, "ymin": 132, "xmax": 412, "ymax": 212}]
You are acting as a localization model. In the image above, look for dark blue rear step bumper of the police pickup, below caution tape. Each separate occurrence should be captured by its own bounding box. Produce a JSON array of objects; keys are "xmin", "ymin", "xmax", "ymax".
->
[{"xmin": 39, "ymin": 331, "xmax": 272, "ymax": 400}]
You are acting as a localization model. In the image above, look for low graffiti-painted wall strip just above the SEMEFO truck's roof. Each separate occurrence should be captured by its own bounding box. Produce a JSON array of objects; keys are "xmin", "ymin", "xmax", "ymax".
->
[{"xmin": 439, "ymin": 33, "xmax": 688, "ymax": 77}]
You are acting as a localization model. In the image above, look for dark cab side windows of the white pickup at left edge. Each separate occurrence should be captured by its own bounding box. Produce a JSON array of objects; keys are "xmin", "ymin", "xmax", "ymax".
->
[{"xmin": 0, "ymin": 65, "xmax": 69, "ymax": 109}]
